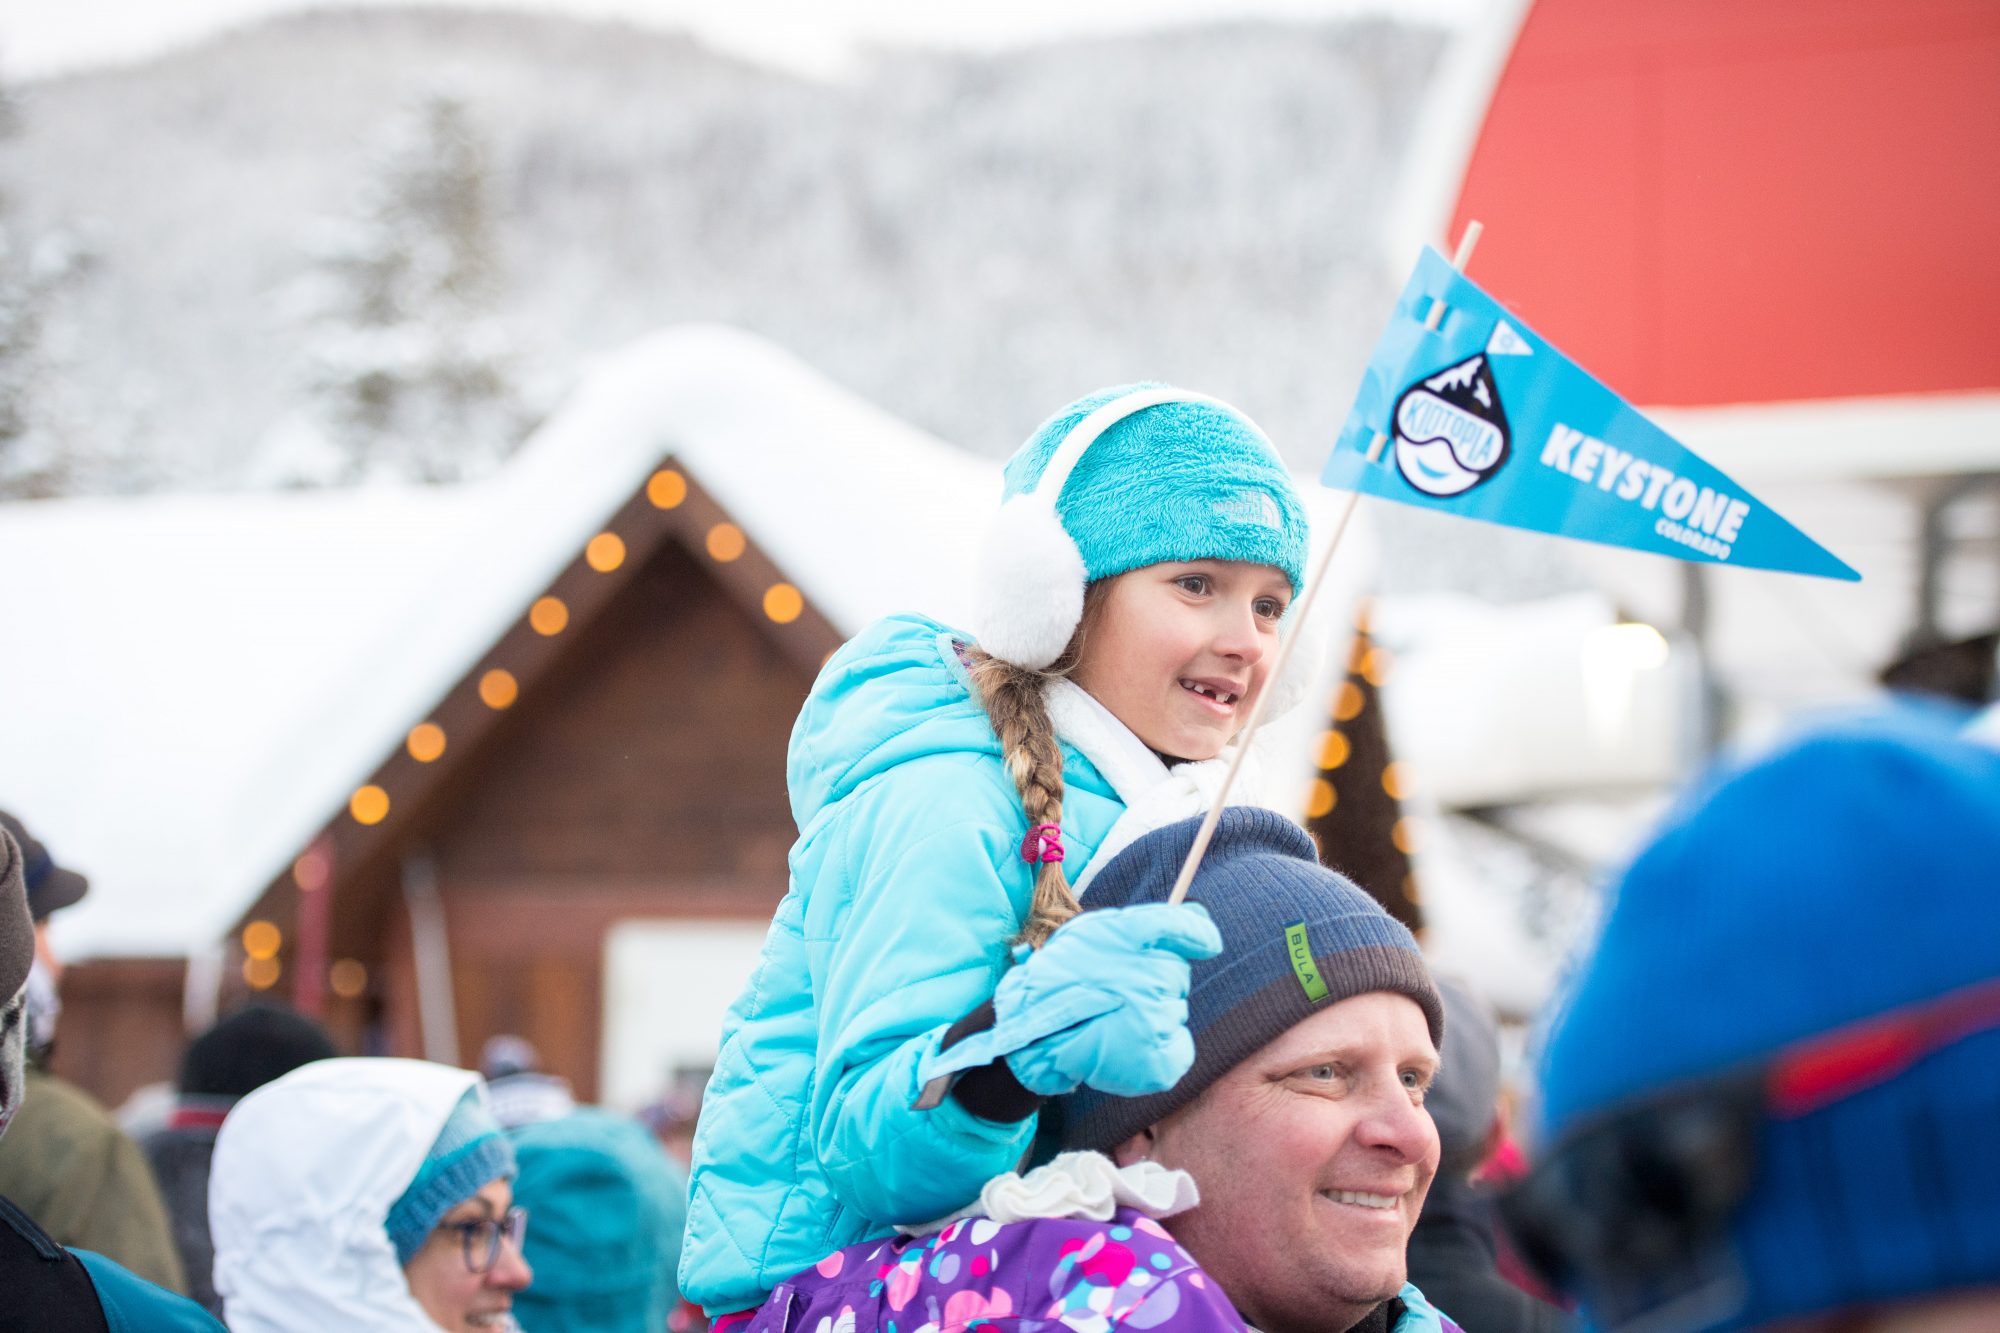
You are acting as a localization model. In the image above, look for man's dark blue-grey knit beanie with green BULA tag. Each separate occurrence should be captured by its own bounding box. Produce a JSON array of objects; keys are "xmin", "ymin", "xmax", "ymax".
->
[{"xmin": 1054, "ymin": 807, "xmax": 1444, "ymax": 1153}]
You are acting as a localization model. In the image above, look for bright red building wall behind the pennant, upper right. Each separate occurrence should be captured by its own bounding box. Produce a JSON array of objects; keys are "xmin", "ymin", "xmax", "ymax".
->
[{"xmin": 1450, "ymin": 0, "xmax": 2000, "ymax": 404}]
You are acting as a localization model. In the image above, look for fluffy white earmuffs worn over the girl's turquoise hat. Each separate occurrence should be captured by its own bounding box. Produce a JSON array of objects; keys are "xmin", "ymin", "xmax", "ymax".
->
[{"xmin": 972, "ymin": 388, "xmax": 1236, "ymax": 671}]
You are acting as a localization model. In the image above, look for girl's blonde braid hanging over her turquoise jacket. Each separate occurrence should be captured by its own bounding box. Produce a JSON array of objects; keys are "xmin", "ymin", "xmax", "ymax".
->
[{"xmin": 966, "ymin": 578, "xmax": 1110, "ymax": 949}]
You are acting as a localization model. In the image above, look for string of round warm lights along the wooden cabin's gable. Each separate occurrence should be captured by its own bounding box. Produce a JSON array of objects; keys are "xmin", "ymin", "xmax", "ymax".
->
[{"xmin": 240, "ymin": 466, "xmax": 806, "ymax": 999}]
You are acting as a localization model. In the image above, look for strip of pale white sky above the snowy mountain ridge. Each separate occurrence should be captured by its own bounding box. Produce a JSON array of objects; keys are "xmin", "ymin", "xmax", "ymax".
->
[{"xmin": 0, "ymin": 0, "xmax": 1490, "ymax": 80}]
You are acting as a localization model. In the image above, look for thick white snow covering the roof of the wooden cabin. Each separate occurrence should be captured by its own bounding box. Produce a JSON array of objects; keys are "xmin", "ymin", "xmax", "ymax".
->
[{"xmin": 0, "ymin": 326, "xmax": 1374, "ymax": 959}]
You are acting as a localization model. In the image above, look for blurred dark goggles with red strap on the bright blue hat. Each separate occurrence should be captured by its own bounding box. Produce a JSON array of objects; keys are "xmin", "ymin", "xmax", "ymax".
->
[{"xmin": 1498, "ymin": 964, "xmax": 2000, "ymax": 1329}]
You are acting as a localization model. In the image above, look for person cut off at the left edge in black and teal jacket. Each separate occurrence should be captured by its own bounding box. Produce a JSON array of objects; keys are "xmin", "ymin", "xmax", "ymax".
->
[{"xmin": 0, "ymin": 831, "xmax": 222, "ymax": 1333}]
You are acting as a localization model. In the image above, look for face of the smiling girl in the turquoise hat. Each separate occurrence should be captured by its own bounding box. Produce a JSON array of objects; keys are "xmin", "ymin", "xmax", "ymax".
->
[{"xmin": 1072, "ymin": 560, "xmax": 1292, "ymax": 759}]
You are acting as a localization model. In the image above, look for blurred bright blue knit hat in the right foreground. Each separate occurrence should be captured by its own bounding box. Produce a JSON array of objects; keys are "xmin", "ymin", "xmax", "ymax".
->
[{"xmin": 1542, "ymin": 711, "xmax": 2000, "ymax": 1329}]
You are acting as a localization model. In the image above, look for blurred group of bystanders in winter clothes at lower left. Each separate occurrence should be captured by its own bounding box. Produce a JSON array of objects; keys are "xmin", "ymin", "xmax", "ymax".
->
[{"xmin": 0, "ymin": 813, "xmax": 704, "ymax": 1333}]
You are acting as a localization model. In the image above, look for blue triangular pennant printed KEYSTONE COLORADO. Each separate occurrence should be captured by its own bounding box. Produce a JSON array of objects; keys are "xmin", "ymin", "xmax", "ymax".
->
[{"xmin": 1320, "ymin": 248, "xmax": 1860, "ymax": 578}]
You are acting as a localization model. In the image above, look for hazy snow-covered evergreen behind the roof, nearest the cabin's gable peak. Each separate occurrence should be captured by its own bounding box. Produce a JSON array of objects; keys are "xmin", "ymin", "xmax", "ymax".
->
[{"xmin": 290, "ymin": 92, "xmax": 526, "ymax": 484}]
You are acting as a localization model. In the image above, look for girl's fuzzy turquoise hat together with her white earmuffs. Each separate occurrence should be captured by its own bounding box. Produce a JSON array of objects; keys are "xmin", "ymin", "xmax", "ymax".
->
[{"xmin": 976, "ymin": 384, "xmax": 1310, "ymax": 671}]
